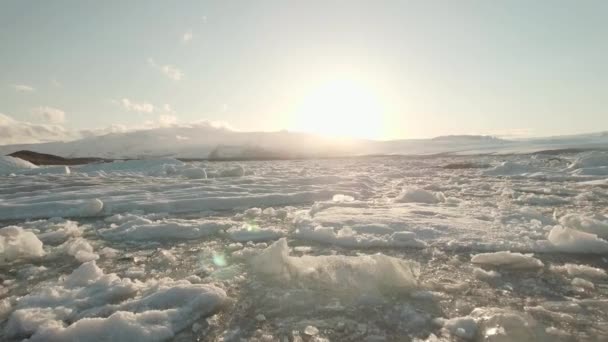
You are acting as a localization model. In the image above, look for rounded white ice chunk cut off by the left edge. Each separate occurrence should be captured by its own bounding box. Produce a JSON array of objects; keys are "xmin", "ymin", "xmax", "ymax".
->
[{"xmin": 0, "ymin": 226, "xmax": 44, "ymax": 264}]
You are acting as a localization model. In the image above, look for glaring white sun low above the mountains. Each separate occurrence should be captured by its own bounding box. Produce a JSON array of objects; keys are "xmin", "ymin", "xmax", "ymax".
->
[{"xmin": 291, "ymin": 80, "xmax": 384, "ymax": 139}]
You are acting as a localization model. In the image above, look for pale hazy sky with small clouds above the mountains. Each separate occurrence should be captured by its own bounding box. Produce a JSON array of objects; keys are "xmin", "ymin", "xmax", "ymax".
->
[{"xmin": 0, "ymin": 0, "xmax": 608, "ymax": 143}]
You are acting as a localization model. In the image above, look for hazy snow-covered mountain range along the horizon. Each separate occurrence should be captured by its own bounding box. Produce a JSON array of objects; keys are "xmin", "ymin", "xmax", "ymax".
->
[{"xmin": 0, "ymin": 125, "xmax": 608, "ymax": 159}]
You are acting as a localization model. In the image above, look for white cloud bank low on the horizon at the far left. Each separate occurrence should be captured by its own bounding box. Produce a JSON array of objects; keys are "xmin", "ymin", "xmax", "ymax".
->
[{"xmin": 0, "ymin": 113, "xmax": 78, "ymax": 145}]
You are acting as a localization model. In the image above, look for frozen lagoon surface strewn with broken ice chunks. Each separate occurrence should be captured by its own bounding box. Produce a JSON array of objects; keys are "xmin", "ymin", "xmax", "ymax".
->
[{"xmin": 0, "ymin": 152, "xmax": 608, "ymax": 342}]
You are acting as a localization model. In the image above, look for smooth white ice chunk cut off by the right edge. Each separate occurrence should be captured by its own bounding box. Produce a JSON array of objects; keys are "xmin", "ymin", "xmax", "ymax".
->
[{"xmin": 548, "ymin": 226, "xmax": 608, "ymax": 254}]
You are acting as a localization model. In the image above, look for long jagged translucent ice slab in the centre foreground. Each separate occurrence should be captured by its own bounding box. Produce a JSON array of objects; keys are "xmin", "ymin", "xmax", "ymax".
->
[{"xmin": 251, "ymin": 238, "xmax": 420, "ymax": 295}]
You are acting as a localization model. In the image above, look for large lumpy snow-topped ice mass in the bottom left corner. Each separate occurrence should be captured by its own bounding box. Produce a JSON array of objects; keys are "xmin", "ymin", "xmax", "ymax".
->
[{"xmin": 5, "ymin": 261, "xmax": 227, "ymax": 341}]
